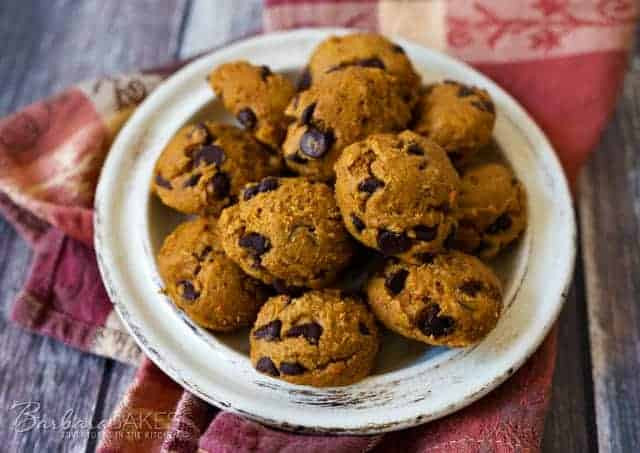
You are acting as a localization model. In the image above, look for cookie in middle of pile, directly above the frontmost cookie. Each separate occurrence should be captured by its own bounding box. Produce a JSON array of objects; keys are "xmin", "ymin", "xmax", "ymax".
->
[{"xmin": 219, "ymin": 178, "xmax": 353, "ymax": 292}]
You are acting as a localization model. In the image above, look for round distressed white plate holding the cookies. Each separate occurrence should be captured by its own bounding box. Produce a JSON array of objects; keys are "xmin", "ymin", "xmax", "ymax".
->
[{"xmin": 95, "ymin": 29, "xmax": 576, "ymax": 434}]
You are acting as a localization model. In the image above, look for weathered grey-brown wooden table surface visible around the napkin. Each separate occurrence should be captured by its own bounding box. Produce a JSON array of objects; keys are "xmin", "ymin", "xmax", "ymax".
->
[{"xmin": 0, "ymin": 0, "xmax": 640, "ymax": 453}]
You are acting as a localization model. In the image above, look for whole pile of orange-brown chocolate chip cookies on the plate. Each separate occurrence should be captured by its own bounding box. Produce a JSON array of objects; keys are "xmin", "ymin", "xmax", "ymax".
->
[{"xmin": 153, "ymin": 34, "xmax": 526, "ymax": 386}]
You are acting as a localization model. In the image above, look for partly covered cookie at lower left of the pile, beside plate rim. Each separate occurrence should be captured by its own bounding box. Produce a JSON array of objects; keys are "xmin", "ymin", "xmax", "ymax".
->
[{"xmin": 158, "ymin": 218, "xmax": 268, "ymax": 332}]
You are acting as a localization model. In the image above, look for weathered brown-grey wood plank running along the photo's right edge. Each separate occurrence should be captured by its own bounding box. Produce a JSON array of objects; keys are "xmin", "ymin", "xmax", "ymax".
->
[{"xmin": 579, "ymin": 56, "xmax": 640, "ymax": 452}]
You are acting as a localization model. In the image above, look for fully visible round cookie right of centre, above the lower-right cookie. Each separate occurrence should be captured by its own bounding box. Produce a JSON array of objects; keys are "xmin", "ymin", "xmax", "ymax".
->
[{"xmin": 335, "ymin": 131, "xmax": 459, "ymax": 263}]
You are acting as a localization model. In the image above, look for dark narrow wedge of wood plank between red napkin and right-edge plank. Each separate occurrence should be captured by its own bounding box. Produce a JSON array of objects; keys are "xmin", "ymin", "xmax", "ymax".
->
[{"xmin": 542, "ymin": 260, "xmax": 598, "ymax": 453}]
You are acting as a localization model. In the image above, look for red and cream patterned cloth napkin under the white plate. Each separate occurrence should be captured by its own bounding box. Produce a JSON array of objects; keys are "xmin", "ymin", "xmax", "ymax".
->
[{"xmin": 0, "ymin": 0, "xmax": 638, "ymax": 452}]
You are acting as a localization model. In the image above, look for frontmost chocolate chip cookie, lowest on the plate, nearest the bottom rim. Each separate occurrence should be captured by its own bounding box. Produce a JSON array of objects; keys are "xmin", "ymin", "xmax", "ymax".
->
[{"xmin": 250, "ymin": 290, "xmax": 379, "ymax": 387}]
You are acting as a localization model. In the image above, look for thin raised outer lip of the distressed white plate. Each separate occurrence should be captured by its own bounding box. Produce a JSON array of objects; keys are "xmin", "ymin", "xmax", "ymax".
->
[{"xmin": 94, "ymin": 27, "xmax": 577, "ymax": 434}]
